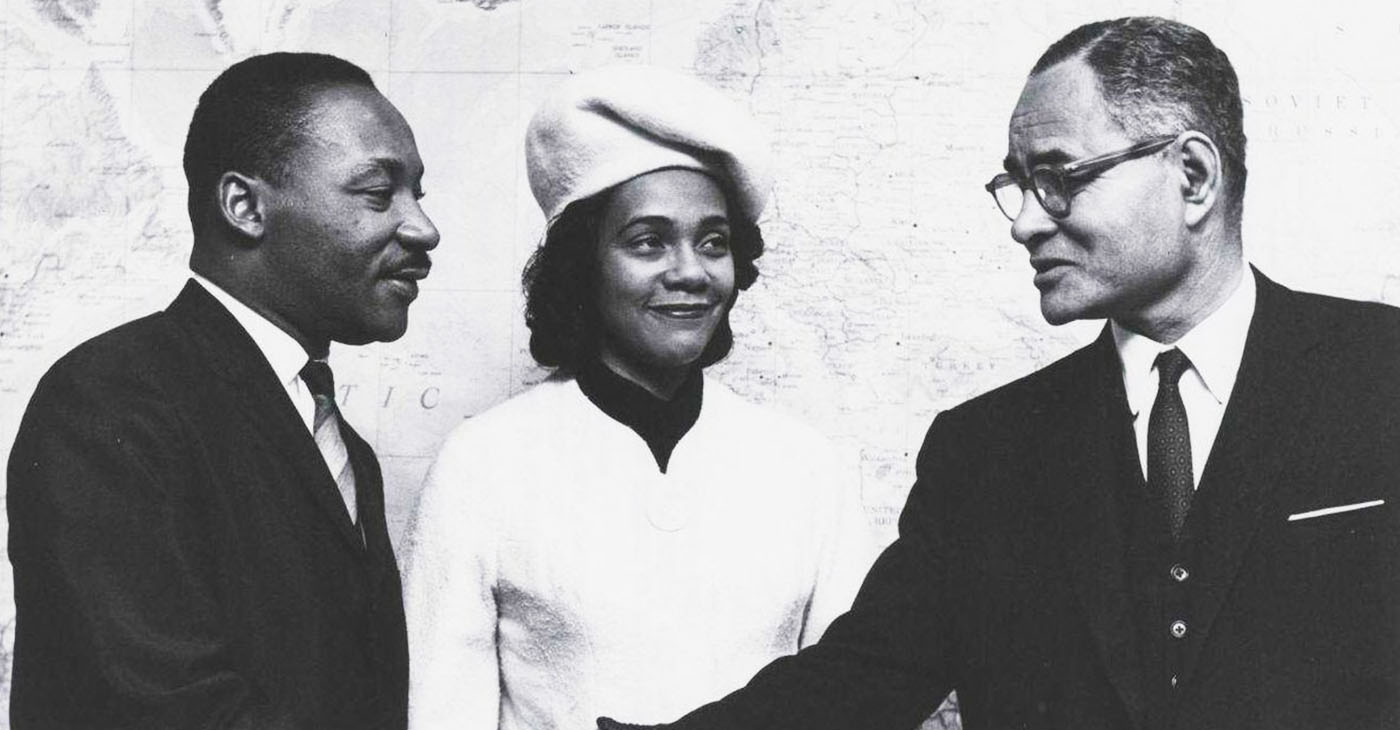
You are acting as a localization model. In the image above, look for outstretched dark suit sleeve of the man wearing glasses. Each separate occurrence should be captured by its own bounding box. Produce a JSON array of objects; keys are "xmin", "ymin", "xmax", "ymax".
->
[{"xmin": 641, "ymin": 416, "xmax": 958, "ymax": 730}]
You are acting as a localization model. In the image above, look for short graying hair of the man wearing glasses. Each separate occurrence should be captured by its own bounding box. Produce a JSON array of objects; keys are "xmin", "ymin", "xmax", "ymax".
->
[{"xmin": 1030, "ymin": 17, "xmax": 1246, "ymax": 226}]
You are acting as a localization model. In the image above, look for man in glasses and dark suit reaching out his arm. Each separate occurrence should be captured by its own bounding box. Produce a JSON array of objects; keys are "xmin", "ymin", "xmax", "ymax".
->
[{"xmin": 601, "ymin": 18, "xmax": 1400, "ymax": 730}]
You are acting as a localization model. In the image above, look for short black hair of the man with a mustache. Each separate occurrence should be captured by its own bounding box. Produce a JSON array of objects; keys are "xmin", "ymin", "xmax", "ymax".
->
[{"xmin": 185, "ymin": 53, "xmax": 375, "ymax": 230}]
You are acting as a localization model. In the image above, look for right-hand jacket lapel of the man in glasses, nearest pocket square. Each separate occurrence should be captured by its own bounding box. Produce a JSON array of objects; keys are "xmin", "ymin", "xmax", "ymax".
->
[{"xmin": 1182, "ymin": 272, "xmax": 1322, "ymax": 684}]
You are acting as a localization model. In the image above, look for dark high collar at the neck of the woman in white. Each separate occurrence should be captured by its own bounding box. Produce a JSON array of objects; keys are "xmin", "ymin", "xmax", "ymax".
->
[{"xmin": 577, "ymin": 361, "xmax": 704, "ymax": 474}]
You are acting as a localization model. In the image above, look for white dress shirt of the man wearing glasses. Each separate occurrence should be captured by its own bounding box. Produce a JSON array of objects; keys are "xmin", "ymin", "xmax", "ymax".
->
[{"xmin": 1112, "ymin": 265, "xmax": 1256, "ymax": 486}]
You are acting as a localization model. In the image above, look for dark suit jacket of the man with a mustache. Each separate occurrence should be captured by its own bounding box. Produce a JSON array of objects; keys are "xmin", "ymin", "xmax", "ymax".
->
[{"xmin": 8, "ymin": 282, "xmax": 407, "ymax": 730}]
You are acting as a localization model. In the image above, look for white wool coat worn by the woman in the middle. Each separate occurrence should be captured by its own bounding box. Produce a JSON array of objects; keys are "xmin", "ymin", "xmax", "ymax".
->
[{"xmin": 403, "ymin": 377, "xmax": 875, "ymax": 730}]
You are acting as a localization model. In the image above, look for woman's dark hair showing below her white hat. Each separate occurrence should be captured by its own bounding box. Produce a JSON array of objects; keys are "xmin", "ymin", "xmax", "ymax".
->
[{"xmin": 521, "ymin": 175, "xmax": 763, "ymax": 373}]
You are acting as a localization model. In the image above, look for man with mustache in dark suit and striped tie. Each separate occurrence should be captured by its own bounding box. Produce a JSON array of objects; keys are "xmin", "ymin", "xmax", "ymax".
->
[{"xmin": 8, "ymin": 53, "xmax": 438, "ymax": 730}]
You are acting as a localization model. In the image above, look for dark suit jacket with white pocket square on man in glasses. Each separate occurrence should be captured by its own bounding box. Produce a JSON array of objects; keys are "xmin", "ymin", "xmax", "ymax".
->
[{"xmin": 652, "ymin": 270, "xmax": 1400, "ymax": 730}]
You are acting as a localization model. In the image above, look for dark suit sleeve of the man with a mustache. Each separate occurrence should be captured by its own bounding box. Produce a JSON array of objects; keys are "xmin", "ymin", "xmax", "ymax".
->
[{"xmin": 7, "ymin": 366, "xmax": 294, "ymax": 730}]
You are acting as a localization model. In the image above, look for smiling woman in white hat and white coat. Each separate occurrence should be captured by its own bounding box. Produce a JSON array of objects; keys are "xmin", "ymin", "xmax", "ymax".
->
[{"xmin": 405, "ymin": 67, "xmax": 874, "ymax": 730}]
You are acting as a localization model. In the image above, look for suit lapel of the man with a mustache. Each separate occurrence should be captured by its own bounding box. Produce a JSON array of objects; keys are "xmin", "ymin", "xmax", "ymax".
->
[{"xmin": 167, "ymin": 282, "xmax": 378, "ymax": 552}]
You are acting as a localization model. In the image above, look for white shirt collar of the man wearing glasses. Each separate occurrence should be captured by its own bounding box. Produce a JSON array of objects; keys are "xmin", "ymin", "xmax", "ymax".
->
[{"xmin": 1109, "ymin": 265, "xmax": 1256, "ymax": 416}]
